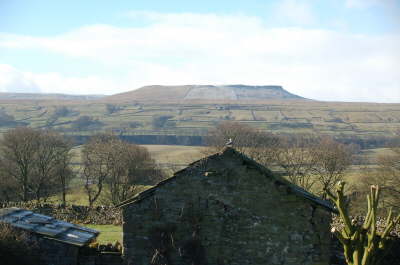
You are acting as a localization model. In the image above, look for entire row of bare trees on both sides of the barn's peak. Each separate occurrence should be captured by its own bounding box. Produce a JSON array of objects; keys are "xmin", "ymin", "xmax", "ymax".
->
[{"xmin": 0, "ymin": 122, "xmax": 400, "ymax": 211}]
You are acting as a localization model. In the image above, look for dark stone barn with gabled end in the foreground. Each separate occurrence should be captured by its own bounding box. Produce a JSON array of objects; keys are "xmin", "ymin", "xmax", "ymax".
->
[{"xmin": 120, "ymin": 147, "xmax": 334, "ymax": 265}]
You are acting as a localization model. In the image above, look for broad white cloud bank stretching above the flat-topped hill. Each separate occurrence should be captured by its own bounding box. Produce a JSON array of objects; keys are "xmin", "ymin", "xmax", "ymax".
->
[{"xmin": 0, "ymin": 12, "xmax": 400, "ymax": 102}]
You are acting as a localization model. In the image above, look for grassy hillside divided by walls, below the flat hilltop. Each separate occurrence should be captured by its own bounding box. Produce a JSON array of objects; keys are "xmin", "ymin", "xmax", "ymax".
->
[{"xmin": 0, "ymin": 100, "xmax": 400, "ymax": 141}]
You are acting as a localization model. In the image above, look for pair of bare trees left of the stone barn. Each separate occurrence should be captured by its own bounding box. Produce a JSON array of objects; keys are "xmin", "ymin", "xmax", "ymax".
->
[{"xmin": 0, "ymin": 127, "xmax": 163, "ymax": 206}]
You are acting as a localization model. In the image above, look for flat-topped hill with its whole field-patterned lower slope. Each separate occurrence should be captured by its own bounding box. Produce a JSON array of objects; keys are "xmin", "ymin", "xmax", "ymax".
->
[{"xmin": 0, "ymin": 85, "xmax": 400, "ymax": 141}]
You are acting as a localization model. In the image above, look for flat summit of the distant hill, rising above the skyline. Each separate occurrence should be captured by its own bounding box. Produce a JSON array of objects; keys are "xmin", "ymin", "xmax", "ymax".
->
[{"xmin": 105, "ymin": 85, "xmax": 305, "ymax": 101}]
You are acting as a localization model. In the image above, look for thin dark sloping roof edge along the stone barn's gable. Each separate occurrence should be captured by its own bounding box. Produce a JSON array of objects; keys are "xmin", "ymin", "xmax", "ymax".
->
[{"xmin": 116, "ymin": 147, "xmax": 337, "ymax": 213}]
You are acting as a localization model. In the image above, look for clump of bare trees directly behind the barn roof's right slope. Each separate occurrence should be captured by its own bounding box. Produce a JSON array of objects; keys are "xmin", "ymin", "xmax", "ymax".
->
[{"xmin": 206, "ymin": 122, "xmax": 353, "ymax": 196}]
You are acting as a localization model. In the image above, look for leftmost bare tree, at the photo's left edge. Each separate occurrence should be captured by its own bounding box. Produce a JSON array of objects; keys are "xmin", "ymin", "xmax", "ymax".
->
[{"xmin": 0, "ymin": 127, "xmax": 71, "ymax": 202}]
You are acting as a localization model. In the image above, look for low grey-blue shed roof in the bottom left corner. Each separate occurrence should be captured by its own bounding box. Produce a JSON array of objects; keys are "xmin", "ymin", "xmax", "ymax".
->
[{"xmin": 0, "ymin": 207, "xmax": 99, "ymax": 247}]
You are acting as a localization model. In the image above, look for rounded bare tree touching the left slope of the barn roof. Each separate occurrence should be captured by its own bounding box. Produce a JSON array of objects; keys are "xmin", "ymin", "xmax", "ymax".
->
[{"xmin": 82, "ymin": 135, "xmax": 162, "ymax": 207}]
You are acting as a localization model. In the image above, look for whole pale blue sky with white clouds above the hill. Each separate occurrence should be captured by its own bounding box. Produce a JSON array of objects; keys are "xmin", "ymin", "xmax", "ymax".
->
[{"xmin": 0, "ymin": 0, "xmax": 400, "ymax": 103}]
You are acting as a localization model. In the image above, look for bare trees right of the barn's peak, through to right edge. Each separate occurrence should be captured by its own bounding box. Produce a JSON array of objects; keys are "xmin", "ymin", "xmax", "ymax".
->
[{"xmin": 206, "ymin": 122, "xmax": 400, "ymax": 212}]
